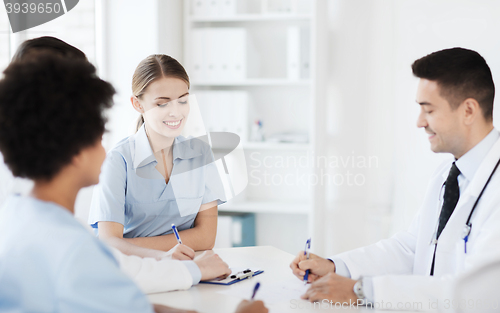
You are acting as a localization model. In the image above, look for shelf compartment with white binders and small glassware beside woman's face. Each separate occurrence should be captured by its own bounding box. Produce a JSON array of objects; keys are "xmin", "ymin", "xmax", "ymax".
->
[{"xmin": 192, "ymin": 87, "xmax": 313, "ymax": 149}]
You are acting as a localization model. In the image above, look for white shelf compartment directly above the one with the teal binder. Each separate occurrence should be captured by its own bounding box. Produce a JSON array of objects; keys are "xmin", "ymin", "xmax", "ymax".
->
[{"xmin": 214, "ymin": 148, "xmax": 316, "ymax": 214}]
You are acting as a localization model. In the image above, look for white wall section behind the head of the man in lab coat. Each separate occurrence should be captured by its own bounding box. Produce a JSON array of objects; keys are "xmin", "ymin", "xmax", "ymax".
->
[{"xmin": 392, "ymin": 0, "xmax": 500, "ymax": 230}]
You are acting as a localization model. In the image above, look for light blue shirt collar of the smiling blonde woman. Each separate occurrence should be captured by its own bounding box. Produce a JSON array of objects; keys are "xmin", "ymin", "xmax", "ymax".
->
[{"xmin": 130, "ymin": 124, "xmax": 201, "ymax": 169}]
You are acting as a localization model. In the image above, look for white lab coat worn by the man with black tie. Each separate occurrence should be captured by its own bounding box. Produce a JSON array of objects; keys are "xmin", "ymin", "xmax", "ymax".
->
[{"xmin": 335, "ymin": 135, "xmax": 500, "ymax": 310}]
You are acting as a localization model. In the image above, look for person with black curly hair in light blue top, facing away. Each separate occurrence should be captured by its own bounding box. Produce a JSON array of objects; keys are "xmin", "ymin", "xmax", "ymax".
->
[{"xmin": 0, "ymin": 54, "xmax": 158, "ymax": 312}]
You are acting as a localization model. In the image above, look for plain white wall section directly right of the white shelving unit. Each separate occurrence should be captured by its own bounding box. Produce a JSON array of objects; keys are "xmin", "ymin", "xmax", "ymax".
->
[{"xmin": 322, "ymin": 0, "xmax": 394, "ymax": 255}]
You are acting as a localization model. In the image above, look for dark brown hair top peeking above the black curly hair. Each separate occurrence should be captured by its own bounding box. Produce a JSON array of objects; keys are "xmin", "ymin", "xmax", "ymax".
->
[{"xmin": 12, "ymin": 36, "xmax": 87, "ymax": 62}]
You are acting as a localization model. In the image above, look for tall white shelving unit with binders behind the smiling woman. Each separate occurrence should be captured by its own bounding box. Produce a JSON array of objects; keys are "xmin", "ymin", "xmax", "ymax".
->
[{"xmin": 183, "ymin": 0, "xmax": 326, "ymax": 251}]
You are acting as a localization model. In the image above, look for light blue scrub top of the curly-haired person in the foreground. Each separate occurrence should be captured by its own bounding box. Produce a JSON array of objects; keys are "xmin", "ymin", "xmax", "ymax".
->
[{"xmin": 0, "ymin": 195, "xmax": 153, "ymax": 313}]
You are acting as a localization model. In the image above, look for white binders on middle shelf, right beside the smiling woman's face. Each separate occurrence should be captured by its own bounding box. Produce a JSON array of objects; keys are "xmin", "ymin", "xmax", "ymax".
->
[{"xmin": 195, "ymin": 90, "xmax": 248, "ymax": 141}]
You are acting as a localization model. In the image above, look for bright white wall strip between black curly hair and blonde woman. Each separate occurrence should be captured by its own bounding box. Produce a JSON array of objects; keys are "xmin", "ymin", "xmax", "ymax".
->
[{"xmin": 98, "ymin": 0, "xmax": 159, "ymax": 149}]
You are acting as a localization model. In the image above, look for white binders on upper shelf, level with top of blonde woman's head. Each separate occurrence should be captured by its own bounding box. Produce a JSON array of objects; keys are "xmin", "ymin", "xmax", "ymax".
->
[{"xmin": 190, "ymin": 27, "xmax": 247, "ymax": 83}]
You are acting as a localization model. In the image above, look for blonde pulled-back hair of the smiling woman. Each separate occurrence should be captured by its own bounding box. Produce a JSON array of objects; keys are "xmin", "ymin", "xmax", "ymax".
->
[{"xmin": 132, "ymin": 54, "xmax": 189, "ymax": 132}]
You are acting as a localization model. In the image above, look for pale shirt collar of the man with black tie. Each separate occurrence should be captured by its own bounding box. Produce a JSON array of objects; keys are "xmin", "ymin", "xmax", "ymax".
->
[{"xmin": 455, "ymin": 128, "xmax": 500, "ymax": 181}]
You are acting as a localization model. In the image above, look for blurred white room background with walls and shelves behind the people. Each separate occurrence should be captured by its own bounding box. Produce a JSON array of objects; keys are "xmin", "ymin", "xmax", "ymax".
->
[{"xmin": 0, "ymin": 0, "xmax": 500, "ymax": 256}]
